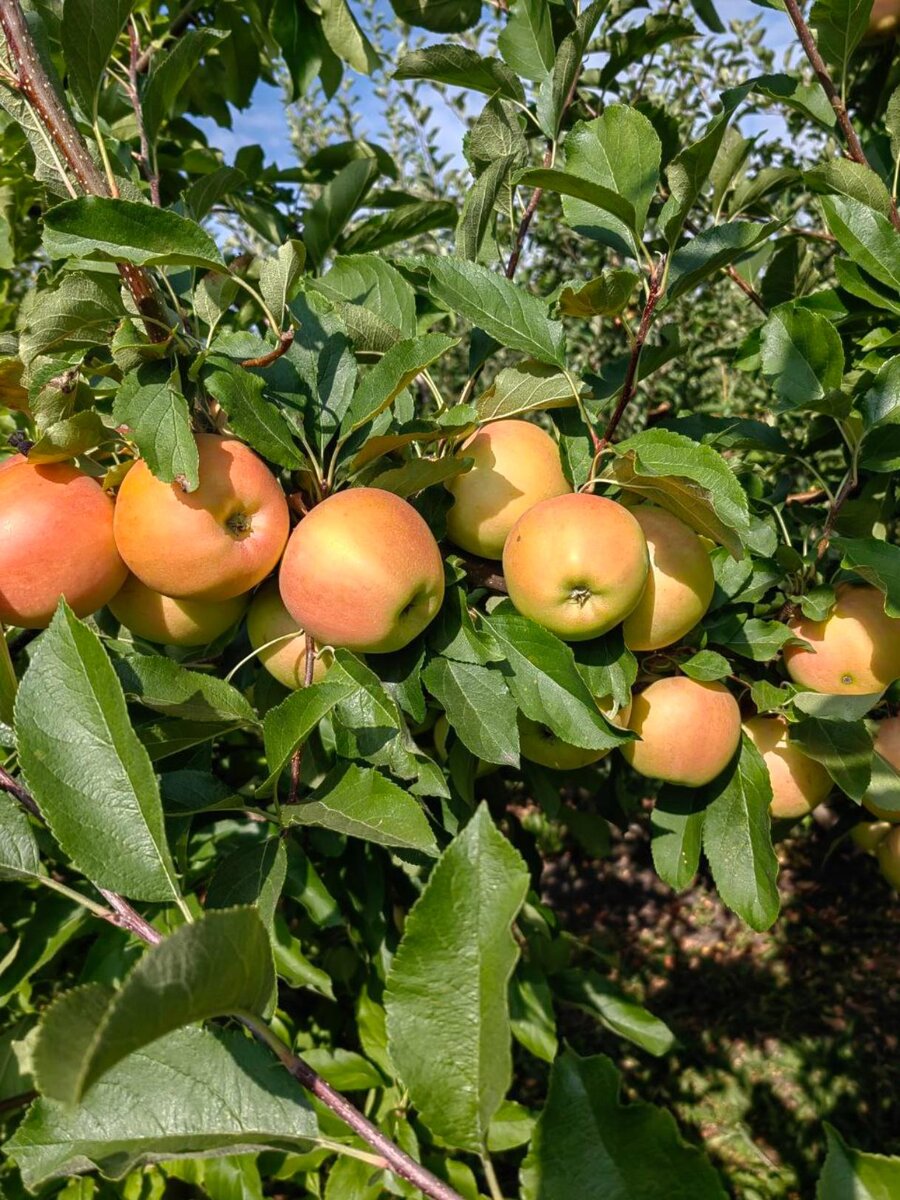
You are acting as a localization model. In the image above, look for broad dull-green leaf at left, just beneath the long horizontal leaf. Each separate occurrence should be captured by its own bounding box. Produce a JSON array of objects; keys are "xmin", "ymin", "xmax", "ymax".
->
[{"xmin": 18, "ymin": 271, "xmax": 125, "ymax": 366}]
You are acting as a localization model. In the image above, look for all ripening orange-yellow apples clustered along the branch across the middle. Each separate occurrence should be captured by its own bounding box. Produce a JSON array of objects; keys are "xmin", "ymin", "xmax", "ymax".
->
[{"xmin": 0, "ymin": 420, "xmax": 900, "ymax": 886}]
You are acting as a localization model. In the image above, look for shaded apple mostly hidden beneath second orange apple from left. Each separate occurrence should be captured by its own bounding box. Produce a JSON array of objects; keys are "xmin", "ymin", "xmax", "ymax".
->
[{"xmin": 107, "ymin": 575, "xmax": 250, "ymax": 646}]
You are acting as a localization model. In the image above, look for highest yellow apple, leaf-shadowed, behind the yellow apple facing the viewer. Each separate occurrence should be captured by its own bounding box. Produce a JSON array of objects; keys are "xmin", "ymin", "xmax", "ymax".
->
[{"xmin": 446, "ymin": 421, "xmax": 571, "ymax": 558}]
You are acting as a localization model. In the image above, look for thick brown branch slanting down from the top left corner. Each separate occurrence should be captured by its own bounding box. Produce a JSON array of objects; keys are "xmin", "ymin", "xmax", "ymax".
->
[{"xmin": 0, "ymin": 0, "xmax": 168, "ymax": 342}]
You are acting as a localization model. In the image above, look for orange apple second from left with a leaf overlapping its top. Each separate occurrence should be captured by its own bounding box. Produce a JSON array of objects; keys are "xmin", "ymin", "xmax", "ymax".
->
[{"xmin": 115, "ymin": 433, "xmax": 290, "ymax": 600}]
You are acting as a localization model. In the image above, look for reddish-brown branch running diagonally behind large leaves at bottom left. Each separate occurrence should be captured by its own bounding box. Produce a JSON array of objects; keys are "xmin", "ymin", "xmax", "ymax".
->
[{"xmin": 0, "ymin": 763, "xmax": 462, "ymax": 1200}]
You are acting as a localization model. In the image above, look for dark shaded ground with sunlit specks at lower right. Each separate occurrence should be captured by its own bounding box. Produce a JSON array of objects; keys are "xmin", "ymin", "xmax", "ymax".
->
[{"xmin": 544, "ymin": 824, "xmax": 900, "ymax": 1200}]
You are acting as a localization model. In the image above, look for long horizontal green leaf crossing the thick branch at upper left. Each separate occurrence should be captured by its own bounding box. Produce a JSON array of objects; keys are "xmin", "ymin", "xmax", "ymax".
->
[{"xmin": 43, "ymin": 196, "xmax": 224, "ymax": 271}]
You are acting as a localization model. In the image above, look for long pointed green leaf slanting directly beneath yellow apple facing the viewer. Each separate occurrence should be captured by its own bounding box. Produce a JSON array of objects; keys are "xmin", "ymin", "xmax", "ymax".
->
[{"xmin": 487, "ymin": 602, "xmax": 628, "ymax": 750}]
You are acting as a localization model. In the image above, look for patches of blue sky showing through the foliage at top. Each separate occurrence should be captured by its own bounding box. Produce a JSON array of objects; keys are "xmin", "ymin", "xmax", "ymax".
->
[{"xmin": 199, "ymin": 0, "xmax": 794, "ymax": 174}]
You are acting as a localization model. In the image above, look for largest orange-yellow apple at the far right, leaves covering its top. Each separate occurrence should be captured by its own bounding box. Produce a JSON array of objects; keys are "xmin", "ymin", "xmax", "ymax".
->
[{"xmin": 785, "ymin": 583, "xmax": 900, "ymax": 696}]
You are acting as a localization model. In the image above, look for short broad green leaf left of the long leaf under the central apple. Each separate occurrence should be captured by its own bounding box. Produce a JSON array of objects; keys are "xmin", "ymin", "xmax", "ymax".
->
[{"xmin": 422, "ymin": 659, "xmax": 518, "ymax": 767}]
